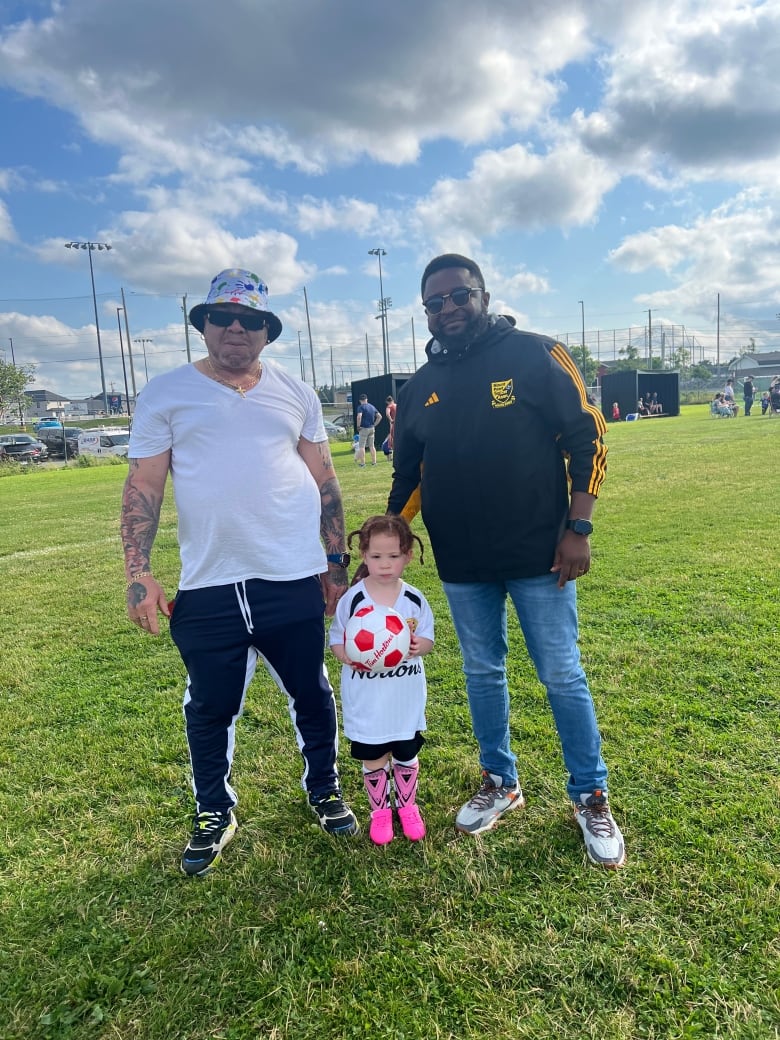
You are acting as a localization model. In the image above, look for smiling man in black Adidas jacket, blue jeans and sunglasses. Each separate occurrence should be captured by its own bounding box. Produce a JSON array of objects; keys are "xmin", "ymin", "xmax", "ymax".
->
[{"xmin": 388, "ymin": 254, "xmax": 626, "ymax": 868}]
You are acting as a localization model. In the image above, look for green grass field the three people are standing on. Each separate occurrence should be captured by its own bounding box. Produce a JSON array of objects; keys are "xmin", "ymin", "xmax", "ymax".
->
[{"xmin": 0, "ymin": 408, "xmax": 780, "ymax": 1040}]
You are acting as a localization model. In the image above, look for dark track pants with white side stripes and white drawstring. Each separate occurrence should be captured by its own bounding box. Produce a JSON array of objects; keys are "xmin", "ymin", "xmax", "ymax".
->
[{"xmin": 171, "ymin": 577, "xmax": 338, "ymax": 812}]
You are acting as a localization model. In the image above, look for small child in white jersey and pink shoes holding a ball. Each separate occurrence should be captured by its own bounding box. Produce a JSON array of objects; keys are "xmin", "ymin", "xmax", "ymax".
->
[{"xmin": 330, "ymin": 515, "xmax": 434, "ymax": 846}]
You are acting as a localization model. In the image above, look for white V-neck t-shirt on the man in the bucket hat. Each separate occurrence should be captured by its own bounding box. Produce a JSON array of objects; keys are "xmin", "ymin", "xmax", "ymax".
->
[{"xmin": 129, "ymin": 360, "xmax": 328, "ymax": 589}]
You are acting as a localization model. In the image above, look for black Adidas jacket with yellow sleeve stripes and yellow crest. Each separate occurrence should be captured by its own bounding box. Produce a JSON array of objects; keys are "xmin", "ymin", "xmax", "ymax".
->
[{"xmin": 388, "ymin": 315, "xmax": 606, "ymax": 581}]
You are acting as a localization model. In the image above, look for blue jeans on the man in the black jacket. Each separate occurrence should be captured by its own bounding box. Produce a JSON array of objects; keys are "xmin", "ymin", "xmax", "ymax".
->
[{"xmin": 444, "ymin": 574, "xmax": 607, "ymax": 799}]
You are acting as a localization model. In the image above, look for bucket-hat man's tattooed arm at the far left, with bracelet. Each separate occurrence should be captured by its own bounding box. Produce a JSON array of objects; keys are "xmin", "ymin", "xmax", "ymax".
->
[{"xmin": 121, "ymin": 451, "xmax": 171, "ymax": 635}]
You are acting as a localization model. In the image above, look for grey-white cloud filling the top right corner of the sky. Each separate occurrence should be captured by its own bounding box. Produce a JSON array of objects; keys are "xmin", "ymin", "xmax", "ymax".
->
[{"xmin": 578, "ymin": 0, "xmax": 780, "ymax": 179}]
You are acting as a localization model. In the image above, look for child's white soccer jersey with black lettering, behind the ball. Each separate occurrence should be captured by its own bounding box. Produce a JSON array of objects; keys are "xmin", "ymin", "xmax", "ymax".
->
[{"xmin": 329, "ymin": 581, "xmax": 434, "ymax": 744}]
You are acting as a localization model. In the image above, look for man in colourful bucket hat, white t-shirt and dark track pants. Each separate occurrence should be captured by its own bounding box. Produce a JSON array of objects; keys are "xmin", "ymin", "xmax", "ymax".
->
[{"xmin": 122, "ymin": 268, "xmax": 358, "ymax": 876}]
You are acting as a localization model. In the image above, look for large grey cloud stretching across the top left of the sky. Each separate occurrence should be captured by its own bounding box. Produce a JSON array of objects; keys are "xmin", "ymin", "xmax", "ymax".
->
[{"xmin": 0, "ymin": 0, "xmax": 590, "ymax": 171}]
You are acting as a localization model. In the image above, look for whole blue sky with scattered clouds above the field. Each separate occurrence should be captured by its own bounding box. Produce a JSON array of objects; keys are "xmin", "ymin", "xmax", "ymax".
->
[{"xmin": 0, "ymin": 0, "xmax": 780, "ymax": 397}]
